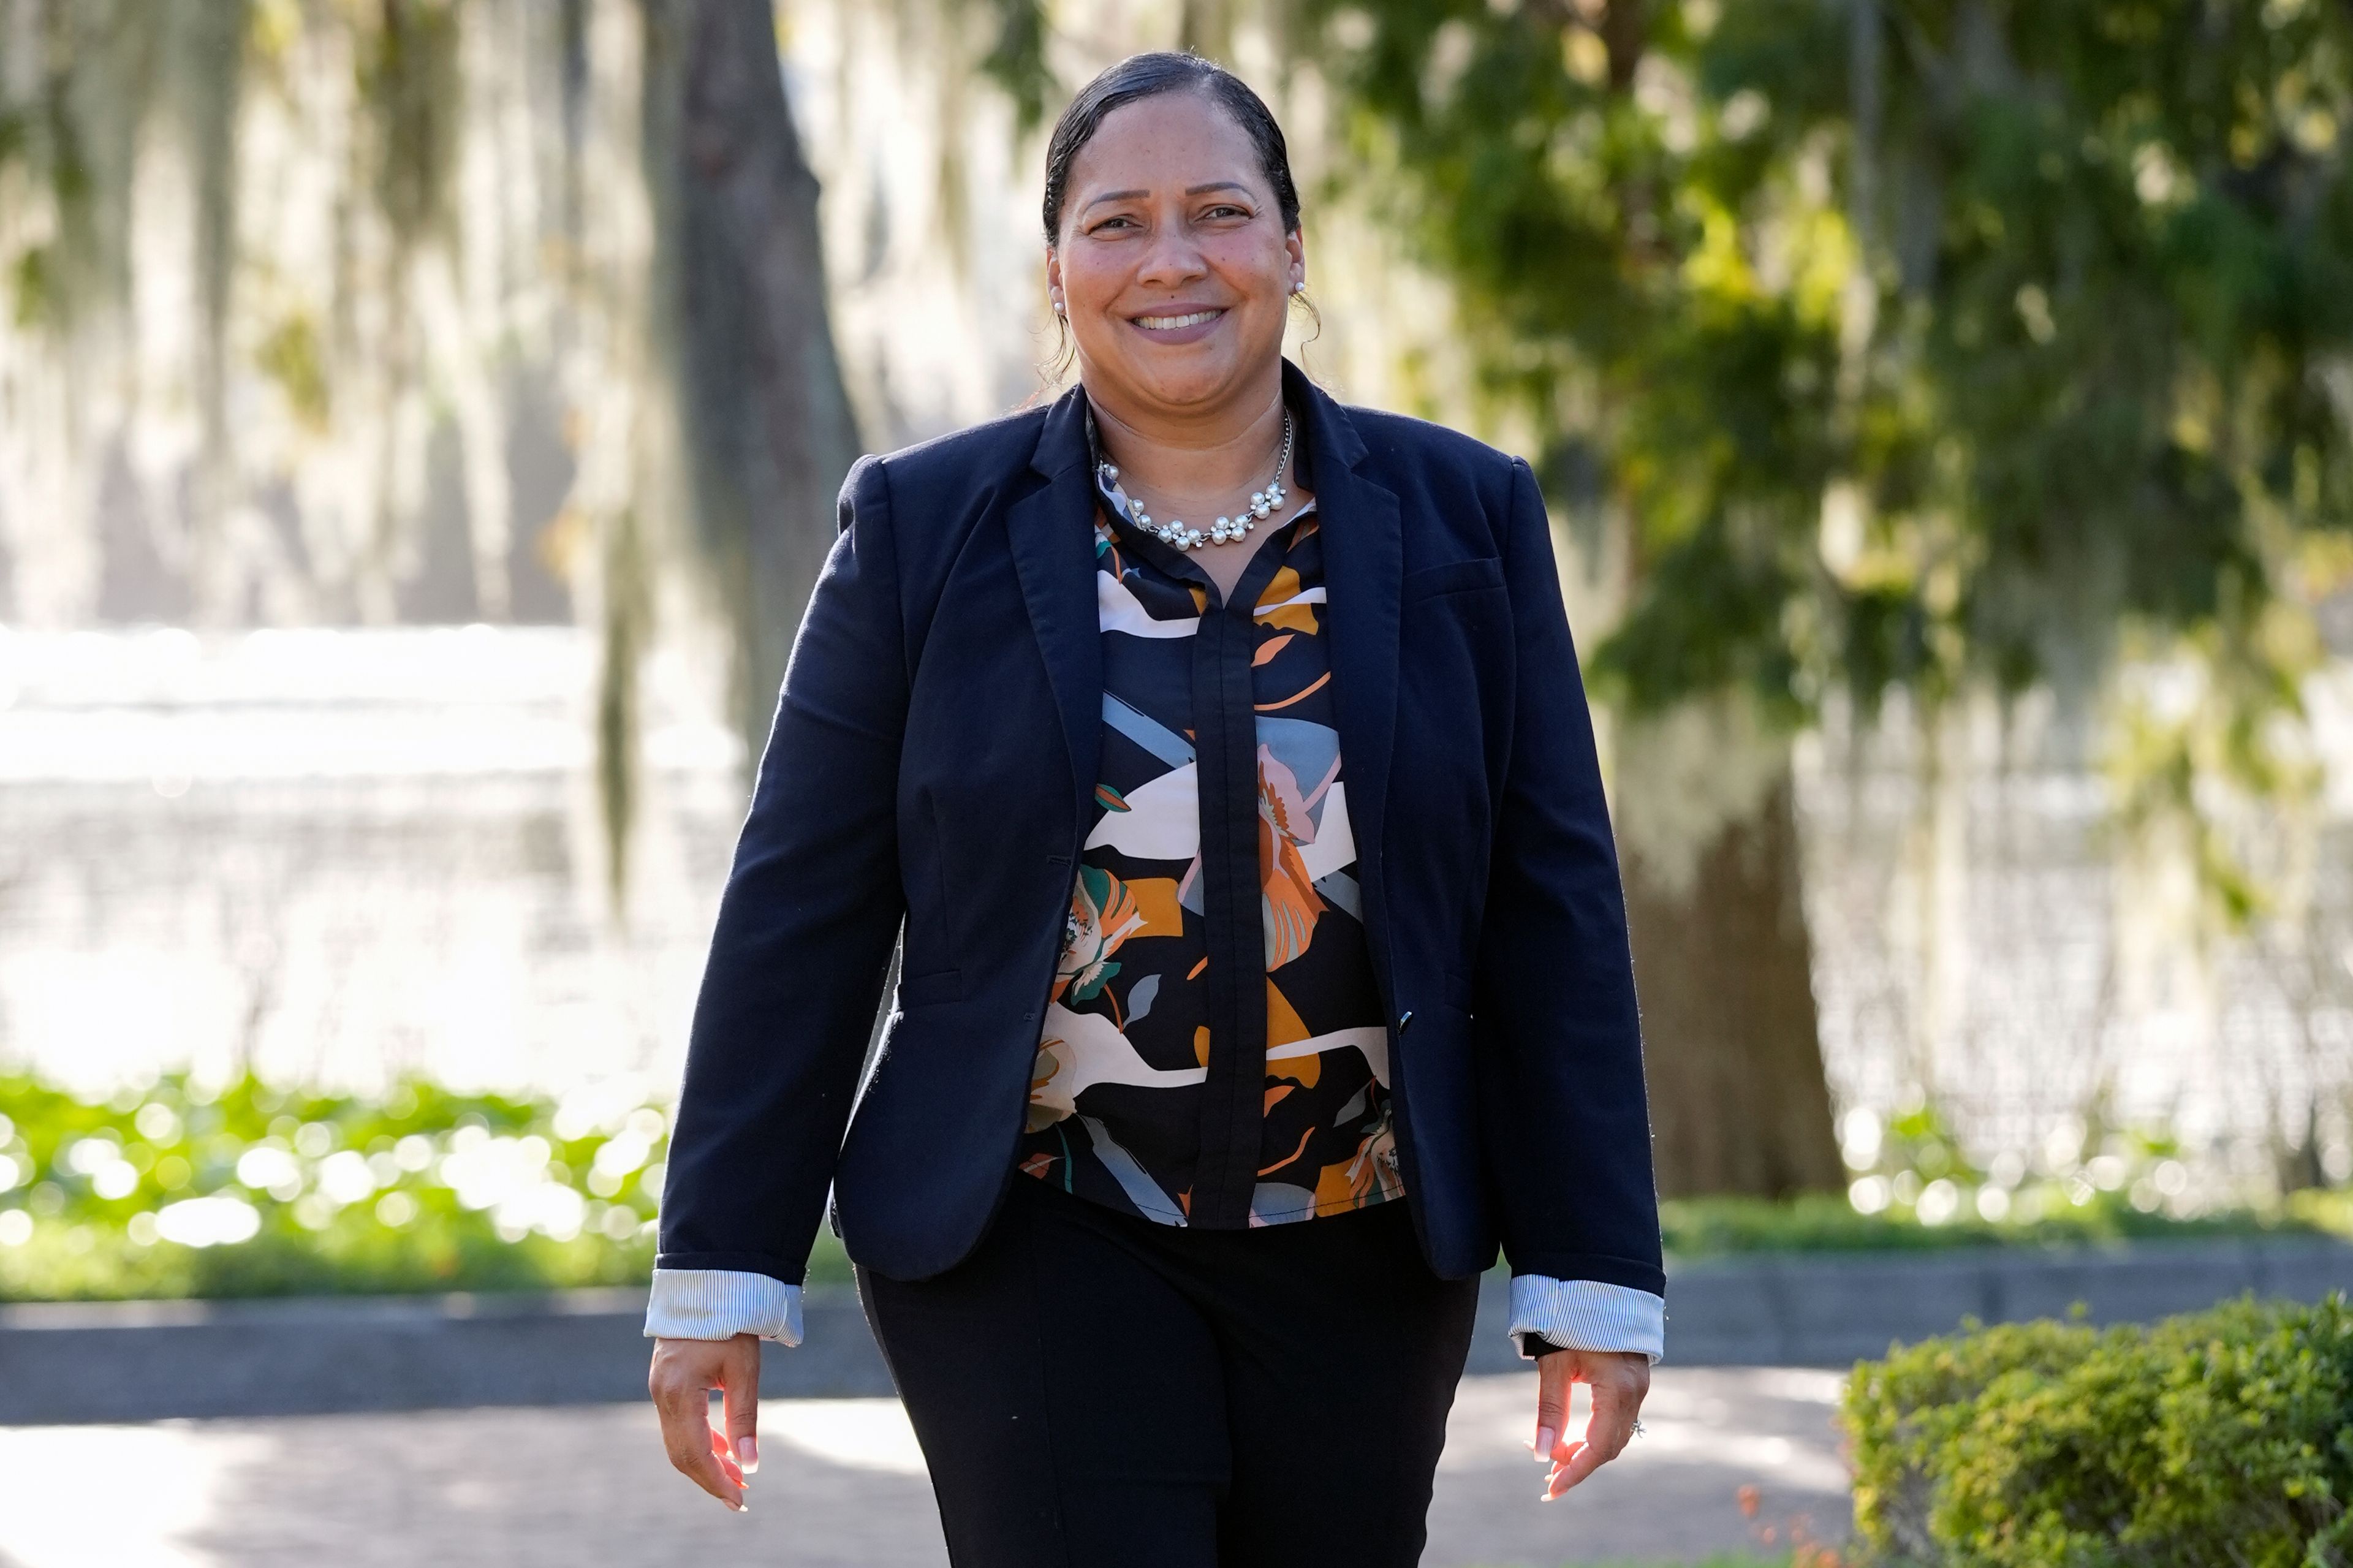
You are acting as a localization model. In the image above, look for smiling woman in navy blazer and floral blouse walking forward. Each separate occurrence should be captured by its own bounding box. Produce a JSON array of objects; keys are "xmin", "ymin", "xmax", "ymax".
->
[{"xmin": 647, "ymin": 54, "xmax": 1664, "ymax": 1568}]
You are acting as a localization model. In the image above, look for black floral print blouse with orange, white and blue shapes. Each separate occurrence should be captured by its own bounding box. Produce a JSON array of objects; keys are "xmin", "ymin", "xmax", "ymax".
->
[{"xmin": 1017, "ymin": 412, "xmax": 1404, "ymax": 1229}]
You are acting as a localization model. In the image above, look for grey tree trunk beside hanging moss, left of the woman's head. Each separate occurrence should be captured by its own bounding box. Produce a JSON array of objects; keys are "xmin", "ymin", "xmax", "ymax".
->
[{"xmin": 645, "ymin": 0, "xmax": 859, "ymax": 756}]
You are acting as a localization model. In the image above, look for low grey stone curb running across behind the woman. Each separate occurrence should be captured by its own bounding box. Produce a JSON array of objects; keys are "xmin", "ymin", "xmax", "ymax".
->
[{"xmin": 0, "ymin": 1238, "xmax": 2353, "ymax": 1425}]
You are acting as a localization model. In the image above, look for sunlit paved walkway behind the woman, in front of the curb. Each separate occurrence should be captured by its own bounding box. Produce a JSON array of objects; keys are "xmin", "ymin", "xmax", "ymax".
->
[{"xmin": 0, "ymin": 1366, "xmax": 1847, "ymax": 1568}]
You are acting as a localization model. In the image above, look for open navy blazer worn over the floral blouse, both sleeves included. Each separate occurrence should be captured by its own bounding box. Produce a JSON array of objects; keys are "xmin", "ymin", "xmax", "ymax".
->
[{"xmin": 659, "ymin": 365, "xmax": 1666, "ymax": 1295}]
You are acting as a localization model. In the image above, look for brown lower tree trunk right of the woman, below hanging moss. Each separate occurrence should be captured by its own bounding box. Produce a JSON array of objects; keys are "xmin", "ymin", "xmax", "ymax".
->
[{"xmin": 1616, "ymin": 704, "xmax": 1845, "ymax": 1199}]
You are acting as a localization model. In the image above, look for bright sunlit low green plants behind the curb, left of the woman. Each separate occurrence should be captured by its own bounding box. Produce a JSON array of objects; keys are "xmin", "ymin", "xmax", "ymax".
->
[{"xmin": 0, "ymin": 1074, "xmax": 849, "ymax": 1300}]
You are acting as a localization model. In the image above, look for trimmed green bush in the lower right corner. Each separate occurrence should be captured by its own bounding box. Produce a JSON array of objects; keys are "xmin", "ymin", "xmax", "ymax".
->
[{"xmin": 1843, "ymin": 1295, "xmax": 2353, "ymax": 1568}]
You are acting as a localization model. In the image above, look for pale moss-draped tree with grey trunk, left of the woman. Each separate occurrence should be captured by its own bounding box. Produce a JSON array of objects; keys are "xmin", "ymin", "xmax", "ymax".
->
[{"xmin": 0, "ymin": 0, "xmax": 859, "ymax": 892}]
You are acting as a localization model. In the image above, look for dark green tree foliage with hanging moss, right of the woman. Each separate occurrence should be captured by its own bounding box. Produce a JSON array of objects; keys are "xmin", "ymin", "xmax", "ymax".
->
[{"xmin": 1303, "ymin": 0, "xmax": 2353, "ymax": 925}]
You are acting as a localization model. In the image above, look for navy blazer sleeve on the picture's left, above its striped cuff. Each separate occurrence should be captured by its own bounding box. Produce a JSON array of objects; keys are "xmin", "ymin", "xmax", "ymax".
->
[{"xmin": 656, "ymin": 456, "xmax": 908, "ymax": 1286}]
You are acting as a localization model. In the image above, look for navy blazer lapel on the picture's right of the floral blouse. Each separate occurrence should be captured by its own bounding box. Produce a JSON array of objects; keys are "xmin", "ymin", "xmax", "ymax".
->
[{"xmin": 1283, "ymin": 360, "xmax": 1404, "ymax": 972}]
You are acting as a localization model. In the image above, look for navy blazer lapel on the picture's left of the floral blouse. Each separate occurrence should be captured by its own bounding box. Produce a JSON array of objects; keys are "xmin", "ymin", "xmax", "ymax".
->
[{"xmin": 1005, "ymin": 386, "xmax": 1104, "ymax": 822}]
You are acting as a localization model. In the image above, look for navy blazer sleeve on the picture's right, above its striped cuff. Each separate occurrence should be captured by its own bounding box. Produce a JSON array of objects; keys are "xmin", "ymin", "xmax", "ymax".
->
[{"xmin": 1473, "ymin": 459, "xmax": 1666, "ymax": 1297}]
